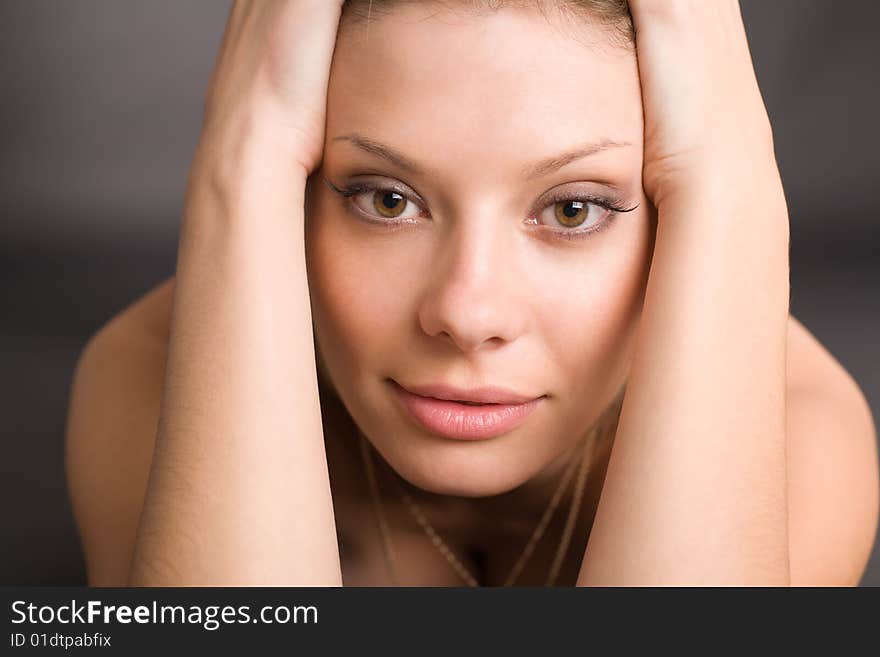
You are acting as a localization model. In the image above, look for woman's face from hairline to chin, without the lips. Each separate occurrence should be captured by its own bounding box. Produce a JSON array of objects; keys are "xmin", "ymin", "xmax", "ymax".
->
[{"xmin": 306, "ymin": 4, "xmax": 654, "ymax": 497}]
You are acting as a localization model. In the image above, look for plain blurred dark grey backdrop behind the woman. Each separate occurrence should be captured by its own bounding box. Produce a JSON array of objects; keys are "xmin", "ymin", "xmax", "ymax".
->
[{"xmin": 0, "ymin": 0, "xmax": 880, "ymax": 586}]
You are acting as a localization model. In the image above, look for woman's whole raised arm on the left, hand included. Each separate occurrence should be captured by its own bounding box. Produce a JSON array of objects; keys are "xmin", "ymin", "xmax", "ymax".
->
[{"xmin": 129, "ymin": 0, "xmax": 341, "ymax": 586}]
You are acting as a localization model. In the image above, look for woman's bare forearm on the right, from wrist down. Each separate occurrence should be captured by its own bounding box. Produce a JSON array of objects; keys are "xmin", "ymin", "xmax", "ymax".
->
[{"xmin": 578, "ymin": 173, "xmax": 789, "ymax": 585}]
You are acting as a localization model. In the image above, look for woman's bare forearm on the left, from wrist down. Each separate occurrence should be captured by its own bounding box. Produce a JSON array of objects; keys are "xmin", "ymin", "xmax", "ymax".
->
[{"xmin": 131, "ymin": 127, "xmax": 341, "ymax": 586}]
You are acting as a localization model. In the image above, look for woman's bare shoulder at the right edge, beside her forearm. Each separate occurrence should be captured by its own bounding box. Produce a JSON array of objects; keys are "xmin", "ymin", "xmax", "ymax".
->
[{"xmin": 786, "ymin": 317, "xmax": 880, "ymax": 586}]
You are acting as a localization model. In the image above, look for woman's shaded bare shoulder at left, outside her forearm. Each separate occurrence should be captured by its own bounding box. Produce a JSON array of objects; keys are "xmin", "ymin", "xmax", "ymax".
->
[{"xmin": 65, "ymin": 278, "xmax": 174, "ymax": 586}]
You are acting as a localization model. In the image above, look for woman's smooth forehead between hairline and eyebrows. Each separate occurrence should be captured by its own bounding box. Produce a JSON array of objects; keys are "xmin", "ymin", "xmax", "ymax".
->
[{"xmin": 327, "ymin": 3, "xmax": 642, "ymax": 177}]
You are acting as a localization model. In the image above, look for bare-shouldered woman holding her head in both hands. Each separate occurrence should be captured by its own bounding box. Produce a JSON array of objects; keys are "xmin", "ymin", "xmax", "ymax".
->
[{"xmin": 62, "ymin": 0, "xmax": 878, "ymax": 586}]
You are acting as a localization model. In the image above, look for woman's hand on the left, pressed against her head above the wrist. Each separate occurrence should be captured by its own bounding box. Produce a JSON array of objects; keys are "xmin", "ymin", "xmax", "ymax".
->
[{"xmin": 203, "ymin": 0, "xmax": 343, "ymax": 174}]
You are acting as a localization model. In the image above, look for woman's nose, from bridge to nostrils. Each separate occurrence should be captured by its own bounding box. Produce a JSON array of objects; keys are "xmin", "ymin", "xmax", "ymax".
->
[{"xmin": 419, "ymin": 216, "xmax": 526, "ymax": 353}]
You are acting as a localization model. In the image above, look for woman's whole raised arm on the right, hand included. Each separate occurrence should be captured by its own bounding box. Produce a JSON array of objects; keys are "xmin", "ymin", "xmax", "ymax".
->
[{"xmin": 578, "ymin": 0, "xmax": 790, "ymax": 585}]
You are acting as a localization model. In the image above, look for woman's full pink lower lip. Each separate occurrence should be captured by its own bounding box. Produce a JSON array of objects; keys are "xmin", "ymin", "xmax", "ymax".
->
[{"xmin": 391, "ymin": 381, "xmax": 543, "ymax": 440}]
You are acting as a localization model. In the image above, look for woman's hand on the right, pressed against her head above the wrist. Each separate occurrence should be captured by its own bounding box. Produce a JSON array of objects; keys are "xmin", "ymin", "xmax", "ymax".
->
[{"xmin": 629, "ymin": 0, "xmax": 781, "ymax": 209}]
